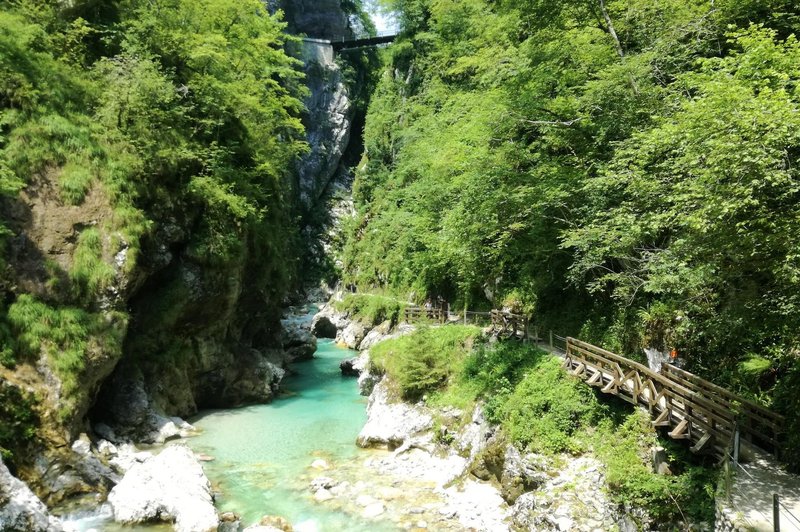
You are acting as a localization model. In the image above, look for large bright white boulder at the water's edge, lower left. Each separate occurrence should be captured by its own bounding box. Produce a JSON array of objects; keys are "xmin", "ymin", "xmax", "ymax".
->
[{"xmin": 108, "ymin": 445, "xmax": 219, "ymax": 532}]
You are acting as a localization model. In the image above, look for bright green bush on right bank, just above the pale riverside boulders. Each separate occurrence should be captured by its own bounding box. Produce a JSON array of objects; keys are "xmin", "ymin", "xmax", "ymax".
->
[{"xmin": 370, "ymin": 325, "xmax": 480, "ymax": 401}]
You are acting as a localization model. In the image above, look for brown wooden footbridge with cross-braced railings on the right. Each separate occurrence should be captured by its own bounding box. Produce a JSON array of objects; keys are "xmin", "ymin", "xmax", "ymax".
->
[{"xmin": 564, "ymin": 338, "xmax": 784, "ymax": 455}]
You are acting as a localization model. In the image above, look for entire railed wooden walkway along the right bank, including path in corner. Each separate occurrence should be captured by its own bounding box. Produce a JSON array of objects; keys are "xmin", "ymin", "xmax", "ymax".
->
[{"xmin": 404, "ymin": 305, "xmax": 800, "ymax": 531}]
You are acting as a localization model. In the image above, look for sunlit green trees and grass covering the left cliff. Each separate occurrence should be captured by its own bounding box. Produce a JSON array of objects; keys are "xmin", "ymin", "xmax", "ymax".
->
[{"xmin": 0, "ymin": 0, "xmax": 305, "ymax": 466}]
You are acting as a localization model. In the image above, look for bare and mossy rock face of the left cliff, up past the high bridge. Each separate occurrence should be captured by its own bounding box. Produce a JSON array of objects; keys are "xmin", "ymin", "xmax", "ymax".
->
[{"xmin": 0, "ymin": 1, "xmax": 360, "ymax": 502}]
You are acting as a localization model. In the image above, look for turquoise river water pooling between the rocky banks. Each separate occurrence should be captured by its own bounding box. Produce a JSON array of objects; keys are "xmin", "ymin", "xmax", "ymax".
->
[{"xmin": 187, "ymin": 341, "xmax": 396, "ymax": 531}]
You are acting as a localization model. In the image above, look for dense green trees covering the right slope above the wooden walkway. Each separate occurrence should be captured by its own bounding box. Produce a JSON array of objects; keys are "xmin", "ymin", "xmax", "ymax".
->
[{"xmin": 343, "ymin": 0, "xmax": 800, "ymax": 465}]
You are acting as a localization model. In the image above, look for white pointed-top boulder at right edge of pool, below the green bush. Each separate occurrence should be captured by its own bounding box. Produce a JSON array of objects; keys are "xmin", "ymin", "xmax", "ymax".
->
[{"xmin": 356, "ymin": 377, "xmax": 433, "ymax": 450}]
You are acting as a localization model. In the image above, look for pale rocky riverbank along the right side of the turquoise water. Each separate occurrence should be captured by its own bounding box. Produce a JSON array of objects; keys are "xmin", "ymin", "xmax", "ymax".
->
[{"xmin": 300, "ymin": 302, "xmax": 641, "ymax": 531}]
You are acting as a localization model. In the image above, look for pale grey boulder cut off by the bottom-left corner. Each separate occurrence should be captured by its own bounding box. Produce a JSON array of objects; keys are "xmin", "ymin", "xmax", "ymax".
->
[{"xmin": 0, "ymin": 460, "xmax": 63, "ymax": 532}]
